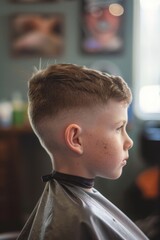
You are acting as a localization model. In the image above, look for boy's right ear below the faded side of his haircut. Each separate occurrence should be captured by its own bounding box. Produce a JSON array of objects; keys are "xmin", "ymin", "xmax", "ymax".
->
[{"xmin": 65, "ymin": 124, "xmax": 83, "ymax": 154}]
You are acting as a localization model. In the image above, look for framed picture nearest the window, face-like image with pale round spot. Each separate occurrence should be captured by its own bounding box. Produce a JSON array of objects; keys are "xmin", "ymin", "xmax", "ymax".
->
[{"xmin": 81, "ymin": 0, "xmax": 125, "ymax": 54}]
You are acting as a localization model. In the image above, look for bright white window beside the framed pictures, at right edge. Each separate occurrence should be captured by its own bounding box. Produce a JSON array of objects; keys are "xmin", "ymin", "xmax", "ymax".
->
[{"xmin": 133, "ymin": 0, "xmax": 160, "ymax": 120}]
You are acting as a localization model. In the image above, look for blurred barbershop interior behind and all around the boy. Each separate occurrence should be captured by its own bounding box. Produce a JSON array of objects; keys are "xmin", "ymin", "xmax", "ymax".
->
[{"xmin": 0, "ymin": 0, "xmax": 160, "ymax": 239}]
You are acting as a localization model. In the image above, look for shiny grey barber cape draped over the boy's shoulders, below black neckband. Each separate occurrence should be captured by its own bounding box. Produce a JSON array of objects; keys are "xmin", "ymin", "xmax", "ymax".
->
[{"xmin": 18, "ymin": 180, "xmax": 148, "ymax": 240}]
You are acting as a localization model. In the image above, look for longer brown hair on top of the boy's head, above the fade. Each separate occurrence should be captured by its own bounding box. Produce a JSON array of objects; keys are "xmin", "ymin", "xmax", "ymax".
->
[{"xmin": 28, "ymin": 64, "xmax": 132, "ymax": 128}]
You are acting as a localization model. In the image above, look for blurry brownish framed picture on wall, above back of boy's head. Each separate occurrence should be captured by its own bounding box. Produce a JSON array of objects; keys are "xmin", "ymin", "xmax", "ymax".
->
[{"xmin": 10, "ymin": 13, "xmax": 64, "ymax": 57}]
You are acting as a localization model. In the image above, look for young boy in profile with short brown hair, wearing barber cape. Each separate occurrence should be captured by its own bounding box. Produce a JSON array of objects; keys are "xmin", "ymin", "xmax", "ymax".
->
[{"xmin": 18, "ymin": 64, "xmax": 147, "ymax": 240}]
